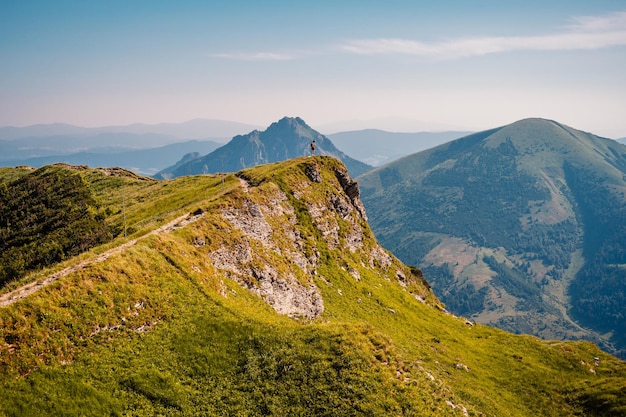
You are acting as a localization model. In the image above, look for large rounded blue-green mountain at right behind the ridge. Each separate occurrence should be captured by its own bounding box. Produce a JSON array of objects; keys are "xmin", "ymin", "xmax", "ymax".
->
[{"xmin": 358, "ymin": 119, "xmax": 626, "ymax": 356}]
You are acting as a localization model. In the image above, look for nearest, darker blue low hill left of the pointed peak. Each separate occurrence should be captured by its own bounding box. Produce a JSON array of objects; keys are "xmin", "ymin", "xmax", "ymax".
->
[{"xmin": 0, "ymin": 140, "xmax": 222, "ymax": 175}]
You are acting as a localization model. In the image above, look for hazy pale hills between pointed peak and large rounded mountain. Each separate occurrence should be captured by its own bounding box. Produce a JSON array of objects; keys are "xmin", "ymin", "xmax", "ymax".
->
[{"xmin": 328, "ymin": 129, "xmax": 470, "ymax": 166}]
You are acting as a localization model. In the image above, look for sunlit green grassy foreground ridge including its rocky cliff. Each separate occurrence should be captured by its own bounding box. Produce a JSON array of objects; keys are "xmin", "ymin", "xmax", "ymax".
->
[{"xmin": 0, "ymin": 157, "xmax": 626, "ymax": 416}]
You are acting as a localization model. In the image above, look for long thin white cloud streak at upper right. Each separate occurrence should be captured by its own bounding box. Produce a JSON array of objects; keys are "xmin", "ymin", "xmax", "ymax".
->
[{"xmin": 340, "ymin": 12, "xmax": 626, "ymax": 59}]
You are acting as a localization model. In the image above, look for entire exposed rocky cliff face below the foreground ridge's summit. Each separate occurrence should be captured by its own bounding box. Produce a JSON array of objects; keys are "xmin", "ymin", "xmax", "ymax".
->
[{"xmin": 208, "ymin": 160, "xmax": 416, "ymax": 319}]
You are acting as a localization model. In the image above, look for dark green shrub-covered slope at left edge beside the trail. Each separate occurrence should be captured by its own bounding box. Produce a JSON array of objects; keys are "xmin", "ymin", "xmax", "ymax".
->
[{"xmin": 0, "ymin": 167, "xmax": 112, "ymax": 286}]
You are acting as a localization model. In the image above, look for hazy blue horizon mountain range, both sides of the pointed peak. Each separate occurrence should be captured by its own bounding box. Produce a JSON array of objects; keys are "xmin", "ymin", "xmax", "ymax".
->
[{"xmin": 0, "ymin": 119, "xmax": 460, "ymax": 175}]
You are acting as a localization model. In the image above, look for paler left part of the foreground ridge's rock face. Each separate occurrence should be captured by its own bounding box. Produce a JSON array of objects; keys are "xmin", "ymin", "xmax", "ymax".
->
[{"xmin": 209, "ymin": 180, "xmax": 324, "ymax": 319}]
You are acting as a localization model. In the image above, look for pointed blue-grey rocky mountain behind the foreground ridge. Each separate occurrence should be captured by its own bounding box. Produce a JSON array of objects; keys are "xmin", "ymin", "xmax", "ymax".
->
[{"xmin": 155, "ymin": 117, "xmax": 371, "ymax": 179}]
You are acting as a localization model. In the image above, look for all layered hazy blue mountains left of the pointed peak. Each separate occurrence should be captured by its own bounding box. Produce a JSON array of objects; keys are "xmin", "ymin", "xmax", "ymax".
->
[{"xmin": 0, "ymin": 119, "xmax": 256, "ymax": 175}]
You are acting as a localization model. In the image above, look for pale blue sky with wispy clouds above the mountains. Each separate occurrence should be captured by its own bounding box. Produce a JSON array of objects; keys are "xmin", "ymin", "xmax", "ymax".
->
[{"xmin": 0, "ymin": 0, "xmax": 626, "ymax": 138}]
